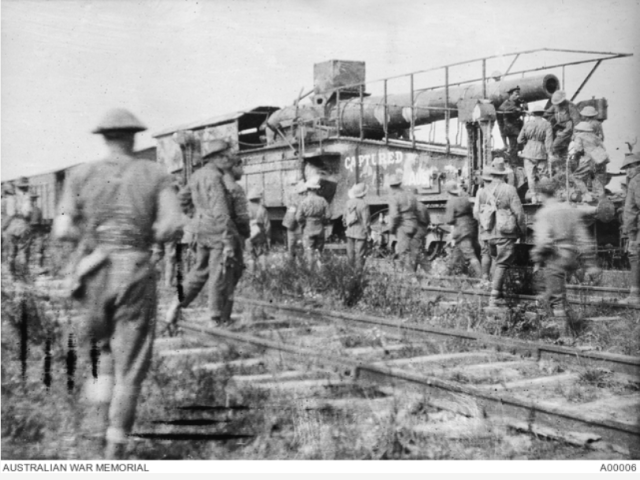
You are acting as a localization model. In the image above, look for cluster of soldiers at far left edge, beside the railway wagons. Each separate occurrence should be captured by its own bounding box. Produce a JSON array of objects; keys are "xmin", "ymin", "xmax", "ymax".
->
[{"xmin": 2, "ymin": 177, "xmax": 47, "ymax": 278}]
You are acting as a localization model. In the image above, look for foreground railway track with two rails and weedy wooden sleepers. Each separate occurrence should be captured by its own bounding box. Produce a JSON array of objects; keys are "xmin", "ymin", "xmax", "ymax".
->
[{"xmin": 152, "ymin": 299, "xmax": 640, "ymax": 458}]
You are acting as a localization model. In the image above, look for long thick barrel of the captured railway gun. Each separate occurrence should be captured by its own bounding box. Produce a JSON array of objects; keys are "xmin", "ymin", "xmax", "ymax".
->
[{"xmin": 335, "ymin": 74, "xmax": 560, "ymax": 135}]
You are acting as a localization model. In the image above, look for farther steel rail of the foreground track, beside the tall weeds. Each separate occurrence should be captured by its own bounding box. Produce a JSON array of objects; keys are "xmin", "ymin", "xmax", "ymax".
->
[{"xmin": 236, "ymin": 297, "xmax": 640, "ymax": 378}]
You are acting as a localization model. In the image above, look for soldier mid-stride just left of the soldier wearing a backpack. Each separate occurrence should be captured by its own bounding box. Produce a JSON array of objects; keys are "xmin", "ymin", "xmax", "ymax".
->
[{"xmin": 444, "ymin": 180, "xmax": 482, "ymax": 277}]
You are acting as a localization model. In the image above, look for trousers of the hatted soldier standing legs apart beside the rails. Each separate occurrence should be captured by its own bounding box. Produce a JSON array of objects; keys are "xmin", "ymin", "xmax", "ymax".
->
[{"xmin": 181, "ymin": 244, "xmax": 244, "ymax": 320}]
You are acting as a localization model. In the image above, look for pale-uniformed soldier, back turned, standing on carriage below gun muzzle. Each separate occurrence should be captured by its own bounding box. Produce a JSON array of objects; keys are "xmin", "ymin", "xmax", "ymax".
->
[{"xmin": 518, "ymin": 107, "xmax": 553, "ymax": 203}]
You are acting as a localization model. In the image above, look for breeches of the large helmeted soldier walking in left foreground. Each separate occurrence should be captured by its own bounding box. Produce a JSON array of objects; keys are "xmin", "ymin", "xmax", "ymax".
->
[{"xmin": 78, "ymin": 251, "xmax": 157, "ymax": 442}]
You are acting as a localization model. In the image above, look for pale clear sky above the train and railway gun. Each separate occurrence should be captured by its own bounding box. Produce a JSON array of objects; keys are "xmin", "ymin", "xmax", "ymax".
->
[{"xmin": 0, "ymin": 0, "xmax": 640, "ymax": 180}]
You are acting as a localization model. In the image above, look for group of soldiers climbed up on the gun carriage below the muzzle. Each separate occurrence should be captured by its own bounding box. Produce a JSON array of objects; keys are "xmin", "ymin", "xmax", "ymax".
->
[{"xmin": 498, "ymin": 87, "xmax": 609, "ymax": 203}]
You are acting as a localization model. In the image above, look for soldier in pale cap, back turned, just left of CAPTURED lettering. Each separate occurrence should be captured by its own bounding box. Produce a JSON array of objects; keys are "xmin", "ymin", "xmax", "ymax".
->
[{"xmin": 296, "ymin": 178, "xmax": 331, "ymax": 266}]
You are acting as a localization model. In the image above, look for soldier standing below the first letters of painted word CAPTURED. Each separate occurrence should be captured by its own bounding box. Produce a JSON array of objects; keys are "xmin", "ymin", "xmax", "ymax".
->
[{"xmin": 342, "ymin": 183, "xmax": 371, "ymax": 269}]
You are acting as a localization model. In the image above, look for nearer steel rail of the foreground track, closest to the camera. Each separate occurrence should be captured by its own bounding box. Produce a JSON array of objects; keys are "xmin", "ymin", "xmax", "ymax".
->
[{"xmin": 182, "ymin": 323, "xmax": 640, "ymax": 452}]
